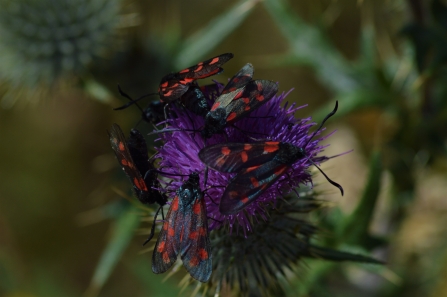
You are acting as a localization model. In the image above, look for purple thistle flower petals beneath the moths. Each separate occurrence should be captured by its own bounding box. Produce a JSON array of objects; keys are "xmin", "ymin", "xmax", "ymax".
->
[{"xmin": 157, "ymin": 82, "xmax": 330, "ymax": 236}]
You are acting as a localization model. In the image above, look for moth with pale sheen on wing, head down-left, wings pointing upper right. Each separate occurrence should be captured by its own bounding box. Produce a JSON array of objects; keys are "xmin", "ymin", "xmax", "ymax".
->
[{"xmin": 201, "ymin": 63, "xmax": 278, "ymax": 139}]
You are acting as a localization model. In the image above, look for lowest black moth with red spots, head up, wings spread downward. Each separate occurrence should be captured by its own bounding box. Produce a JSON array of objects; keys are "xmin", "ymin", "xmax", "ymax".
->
[{"xmin": 152, "ymin": 173, "xmax": 212, "ymax": 282}]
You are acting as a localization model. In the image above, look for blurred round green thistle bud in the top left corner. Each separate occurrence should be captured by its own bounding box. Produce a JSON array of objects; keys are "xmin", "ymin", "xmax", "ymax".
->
[{"xmin": 0, "ymin": 0, "xmax": 121, "ymax": 107}]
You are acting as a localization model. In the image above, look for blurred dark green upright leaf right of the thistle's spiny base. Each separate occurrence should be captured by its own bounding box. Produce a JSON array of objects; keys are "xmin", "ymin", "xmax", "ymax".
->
[{"xmin": 338, "ymin": 151, "xmax": 383, "ymax": 249}]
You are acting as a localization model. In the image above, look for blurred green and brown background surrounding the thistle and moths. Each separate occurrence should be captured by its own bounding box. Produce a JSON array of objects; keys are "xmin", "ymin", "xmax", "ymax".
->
[{"xmin": 0, "ymin": 0, "xmax": 447, "ymax": 297}]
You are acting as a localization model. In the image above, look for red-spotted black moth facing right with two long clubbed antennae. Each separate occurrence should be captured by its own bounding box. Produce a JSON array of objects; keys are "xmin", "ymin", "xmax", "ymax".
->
[{"xmin": 199, "ymin": 102, "xmax": 343, "ymax": 215}]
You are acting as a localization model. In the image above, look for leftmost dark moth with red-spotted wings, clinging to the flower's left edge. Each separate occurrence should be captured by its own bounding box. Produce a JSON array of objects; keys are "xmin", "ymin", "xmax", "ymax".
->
[{"xmin": 109, "ymin": 124, "xmax": 168, "ymax": 245}]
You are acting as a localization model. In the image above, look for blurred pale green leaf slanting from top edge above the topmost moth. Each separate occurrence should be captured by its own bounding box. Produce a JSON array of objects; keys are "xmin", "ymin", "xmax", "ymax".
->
[{"xmin": 174, "ymin": 0, "xmax": 259, "ymax": 69}]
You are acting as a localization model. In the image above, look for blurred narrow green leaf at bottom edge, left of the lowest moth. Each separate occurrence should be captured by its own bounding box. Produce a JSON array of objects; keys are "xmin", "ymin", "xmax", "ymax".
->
[{"xmin": 86, "ymin": 206, "xmax": 140, "ymax": 296}]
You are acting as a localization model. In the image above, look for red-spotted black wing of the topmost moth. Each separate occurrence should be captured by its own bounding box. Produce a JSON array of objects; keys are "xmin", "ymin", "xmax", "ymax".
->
[{"xmin": 158, "ymin": 53, "xmax": 233, "ymax": 103}]
